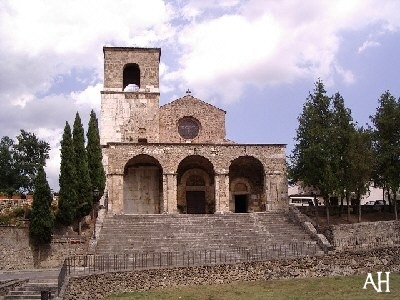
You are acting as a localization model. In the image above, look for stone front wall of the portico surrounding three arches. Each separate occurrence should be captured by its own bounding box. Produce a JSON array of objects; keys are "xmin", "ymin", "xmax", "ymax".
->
[{"xmin": 104, "ymin": 143, "xmax": 287, "ymax": 214}]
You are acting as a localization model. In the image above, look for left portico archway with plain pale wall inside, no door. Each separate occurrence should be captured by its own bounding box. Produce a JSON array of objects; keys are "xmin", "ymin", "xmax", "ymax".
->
[{"xmin": 123, "ymin": 154, "xmax": 162, "ymax": 214}]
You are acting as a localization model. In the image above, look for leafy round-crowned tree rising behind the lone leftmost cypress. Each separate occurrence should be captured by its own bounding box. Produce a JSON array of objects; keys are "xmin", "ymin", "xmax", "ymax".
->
[{"xmin": 14, "ymin": 129, "xmax": 50, "ymax": 192}]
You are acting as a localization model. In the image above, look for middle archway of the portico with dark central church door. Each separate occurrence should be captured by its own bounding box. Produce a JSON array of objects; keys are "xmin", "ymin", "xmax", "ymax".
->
[{"xmin": 177, "ymin": 155, "xmax": 215, "ymax": 214}]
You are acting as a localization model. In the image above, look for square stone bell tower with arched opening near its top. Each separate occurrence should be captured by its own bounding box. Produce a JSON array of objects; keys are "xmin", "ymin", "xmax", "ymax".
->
[{"xmin": 100, "ymin": 47, "xmax": 161, "ymax": 145}]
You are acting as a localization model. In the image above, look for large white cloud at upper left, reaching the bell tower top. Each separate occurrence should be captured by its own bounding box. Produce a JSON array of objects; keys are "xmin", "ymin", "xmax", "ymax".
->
[{"xmin": 0, "ymin": 0, "xmax": 174, "ymax": 98}]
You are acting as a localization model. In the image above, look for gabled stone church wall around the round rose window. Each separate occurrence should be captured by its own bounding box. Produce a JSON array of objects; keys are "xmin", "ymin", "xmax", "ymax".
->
[{"xmin": 160, "ymin": 95, "xmax": 226, "ymax": 144}]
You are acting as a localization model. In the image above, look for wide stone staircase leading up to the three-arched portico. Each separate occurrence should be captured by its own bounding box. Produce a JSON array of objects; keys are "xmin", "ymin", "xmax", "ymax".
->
[{"xmin": 96, "ymin": 212, "xmax": 320, "ymax": 255}]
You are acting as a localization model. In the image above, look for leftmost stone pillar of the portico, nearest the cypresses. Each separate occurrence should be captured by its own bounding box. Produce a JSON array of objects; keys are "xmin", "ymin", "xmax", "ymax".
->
[{"xmin": 107, "ymin": 174, "xmax": 124, "ymax": 214}]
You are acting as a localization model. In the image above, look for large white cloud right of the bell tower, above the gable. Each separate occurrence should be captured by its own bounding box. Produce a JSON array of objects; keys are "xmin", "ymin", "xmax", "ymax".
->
[{"xmin": 165, "ymin": 0, "xmax": 400, "ymax": 102}]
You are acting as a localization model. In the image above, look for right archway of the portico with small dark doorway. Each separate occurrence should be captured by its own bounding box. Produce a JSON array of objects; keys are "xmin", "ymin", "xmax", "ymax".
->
[{"xmin": 229, "ymin": 156, "xmax": 265, "ymax": 213}]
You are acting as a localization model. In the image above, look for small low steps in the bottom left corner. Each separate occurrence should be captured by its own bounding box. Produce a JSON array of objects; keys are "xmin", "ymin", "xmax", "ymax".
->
[{"xmin": 4, "ymin": 278, "xmax": 58, "ymax": 300}]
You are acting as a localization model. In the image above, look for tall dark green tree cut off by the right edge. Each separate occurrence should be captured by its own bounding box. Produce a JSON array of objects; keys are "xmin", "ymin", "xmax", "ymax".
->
[{"xmin": 371, "ymin": 91, "xmax": 400, "ymax": 220}]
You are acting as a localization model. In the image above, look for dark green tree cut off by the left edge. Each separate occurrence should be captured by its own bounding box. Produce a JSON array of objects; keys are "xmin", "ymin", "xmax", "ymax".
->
[{"xmin": 0, "ymin": 136, "xmax": 18, "ymax": 194}]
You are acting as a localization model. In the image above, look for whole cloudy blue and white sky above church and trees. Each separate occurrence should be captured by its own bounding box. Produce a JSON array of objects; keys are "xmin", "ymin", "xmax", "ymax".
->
[{"xmin": 0, "ymin": 0, "xmax": 400, "ymax": 190}]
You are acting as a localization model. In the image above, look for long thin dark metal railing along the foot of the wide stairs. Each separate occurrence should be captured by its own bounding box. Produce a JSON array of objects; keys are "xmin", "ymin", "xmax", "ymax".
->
[{"xmin": 64, "ymin": 242, "xmax": 323, "ymax": 275}]
